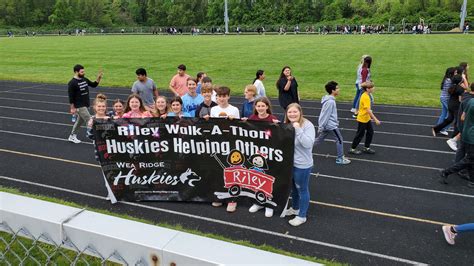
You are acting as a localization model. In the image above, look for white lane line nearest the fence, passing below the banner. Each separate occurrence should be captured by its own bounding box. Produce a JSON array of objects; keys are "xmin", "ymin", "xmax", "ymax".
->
[{"xmin": 0, "ymin": 176, "xmax": 427, "ymax": 265}]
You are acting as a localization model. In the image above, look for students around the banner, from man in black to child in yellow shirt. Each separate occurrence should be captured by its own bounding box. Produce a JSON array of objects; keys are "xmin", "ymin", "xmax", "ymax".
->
[{"xmin": 68, "ymin": 57, "xmax": 388, "ymax": 226}]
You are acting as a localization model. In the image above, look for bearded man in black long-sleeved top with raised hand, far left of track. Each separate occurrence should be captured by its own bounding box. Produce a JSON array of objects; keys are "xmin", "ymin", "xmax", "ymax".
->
[{"xmin": 68, "ymin": 65, "xmax": 103, "ymax": 143}]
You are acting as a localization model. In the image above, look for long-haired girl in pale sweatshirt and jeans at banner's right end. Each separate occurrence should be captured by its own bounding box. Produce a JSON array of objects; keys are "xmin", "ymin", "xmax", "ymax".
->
[{"xmin": 285, "ymin": 103, "xmax": 316, "ymax": 226}]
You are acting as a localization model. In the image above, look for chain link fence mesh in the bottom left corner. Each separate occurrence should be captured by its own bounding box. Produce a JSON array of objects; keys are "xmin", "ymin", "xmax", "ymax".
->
[{"xmin": 0, "ymin": 222, "xmax": 130, "ymax": 266}]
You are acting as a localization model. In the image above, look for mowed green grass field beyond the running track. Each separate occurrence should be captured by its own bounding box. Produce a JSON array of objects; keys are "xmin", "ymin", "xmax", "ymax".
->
[{"xmin": 0, "ymin": 35, "xmax": 474, "ymax": 106}]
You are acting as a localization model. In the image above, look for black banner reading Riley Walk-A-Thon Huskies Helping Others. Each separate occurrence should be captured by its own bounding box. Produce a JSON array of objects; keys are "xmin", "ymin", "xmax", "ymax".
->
[{"xmin": 93, "ymin": 118, "xmax": 294, "ymax": 210}]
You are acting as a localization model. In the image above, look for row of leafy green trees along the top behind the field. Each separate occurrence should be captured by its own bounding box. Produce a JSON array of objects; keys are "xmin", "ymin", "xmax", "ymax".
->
[{"xmin": 0, "ymin": 0, "xmax": 474, "ymax": 28}]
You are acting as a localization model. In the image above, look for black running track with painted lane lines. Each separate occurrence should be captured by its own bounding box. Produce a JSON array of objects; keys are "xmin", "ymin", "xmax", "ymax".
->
[{"xmin": 0, "ymin": 81, "xmax": 474, "ymax": 265}]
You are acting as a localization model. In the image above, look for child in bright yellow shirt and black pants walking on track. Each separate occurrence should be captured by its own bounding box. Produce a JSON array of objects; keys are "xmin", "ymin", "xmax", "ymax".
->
[{"xmin": 349, "ymin": 81, "xmax": 380, "ymax": 155}]
